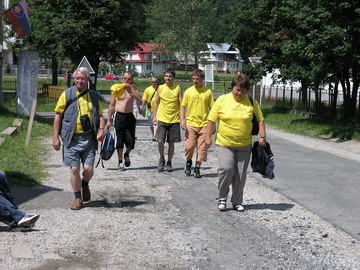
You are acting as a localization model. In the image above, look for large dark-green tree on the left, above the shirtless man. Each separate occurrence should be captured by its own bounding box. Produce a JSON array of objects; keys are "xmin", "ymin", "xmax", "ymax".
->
[{"xmin": 25, "ymin": 0, "xmax": 148, "ymax": 87}]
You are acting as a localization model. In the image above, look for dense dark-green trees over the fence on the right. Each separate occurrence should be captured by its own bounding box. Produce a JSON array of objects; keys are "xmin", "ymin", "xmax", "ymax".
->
[{"xmin": 229, "ymin": 0, "xmax": 360, "ymax": 122}]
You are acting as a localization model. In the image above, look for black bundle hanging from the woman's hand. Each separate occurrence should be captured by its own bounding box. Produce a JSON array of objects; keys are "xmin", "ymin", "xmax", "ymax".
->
[{"xmin": 251, "ymin": 141, "xmax": 275, "ymax": 179}]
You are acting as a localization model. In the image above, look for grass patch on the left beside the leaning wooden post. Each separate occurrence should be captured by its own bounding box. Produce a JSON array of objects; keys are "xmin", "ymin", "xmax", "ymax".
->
[{"xmin": 0, "ymin": 108, "xmax": 52, "ymax": 187}]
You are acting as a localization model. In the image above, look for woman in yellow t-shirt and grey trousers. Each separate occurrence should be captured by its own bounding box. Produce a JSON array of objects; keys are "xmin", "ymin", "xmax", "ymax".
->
[{"xmin": 205, "ymin": 74, "xmax": 266, "ymax": 212}]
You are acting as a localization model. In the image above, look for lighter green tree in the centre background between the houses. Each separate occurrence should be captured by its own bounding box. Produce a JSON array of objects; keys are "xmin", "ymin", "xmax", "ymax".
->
[{"xmin": 148, "ymin": 0, "xmax": 215, "ymax": 77}]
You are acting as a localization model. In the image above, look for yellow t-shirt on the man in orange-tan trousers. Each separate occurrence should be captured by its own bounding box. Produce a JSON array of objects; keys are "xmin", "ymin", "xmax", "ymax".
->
[{"xmin": 181, "ymin": 85, "xmax": 214, "ymax": 127}]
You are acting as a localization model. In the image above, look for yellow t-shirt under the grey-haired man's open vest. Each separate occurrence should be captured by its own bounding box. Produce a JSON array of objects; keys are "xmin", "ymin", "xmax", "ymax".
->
[{"xmin": 55, "ymin": 91, "xmax": 103, "ymax": 134}]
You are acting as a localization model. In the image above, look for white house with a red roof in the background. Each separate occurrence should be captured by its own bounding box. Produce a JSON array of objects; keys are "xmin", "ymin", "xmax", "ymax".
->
[{"xmin": 125, "ymin": 43, "xmax": 176, "ymax": 74}]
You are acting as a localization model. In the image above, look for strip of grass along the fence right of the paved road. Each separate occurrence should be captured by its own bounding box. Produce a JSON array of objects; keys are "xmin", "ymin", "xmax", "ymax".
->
[{"xmin": 261, "ymin": 106, "xmax": 360, "ymax": 140}]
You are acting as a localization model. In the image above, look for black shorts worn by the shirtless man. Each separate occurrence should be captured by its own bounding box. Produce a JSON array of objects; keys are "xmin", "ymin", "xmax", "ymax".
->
[{"xmin": 114, "ymin": 112, "xmax": 136, "ymax": 149}]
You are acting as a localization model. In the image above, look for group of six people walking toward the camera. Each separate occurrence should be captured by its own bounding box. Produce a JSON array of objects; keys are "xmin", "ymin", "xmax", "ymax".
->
[{"xmin": 53, "ymin": 68, "xmax": 267, "ymax": 214}]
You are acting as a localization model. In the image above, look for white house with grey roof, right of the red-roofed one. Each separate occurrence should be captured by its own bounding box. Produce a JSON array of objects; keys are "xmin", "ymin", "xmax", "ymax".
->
[{"xmin": 199, "ymin": 43, "xmax": 244, "ymax": 73}]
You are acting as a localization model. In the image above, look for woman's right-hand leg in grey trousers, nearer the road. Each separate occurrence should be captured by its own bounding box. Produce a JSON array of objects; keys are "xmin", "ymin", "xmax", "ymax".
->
[{"xmin": 231, "ymin": 145, "xmax": 251, "ymax": 205}]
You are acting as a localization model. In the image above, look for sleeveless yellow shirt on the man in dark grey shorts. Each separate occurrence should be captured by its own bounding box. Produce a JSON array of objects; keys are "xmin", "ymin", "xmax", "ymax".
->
[{"xmin": 156, "ymin": 84, "xmax": 180, "ymax": 123}]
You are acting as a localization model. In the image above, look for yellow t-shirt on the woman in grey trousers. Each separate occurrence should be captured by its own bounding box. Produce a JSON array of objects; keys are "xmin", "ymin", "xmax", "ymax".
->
[{"xmin": 208, "ymin": 93, "xmax": 264, "ymax": 147}]
